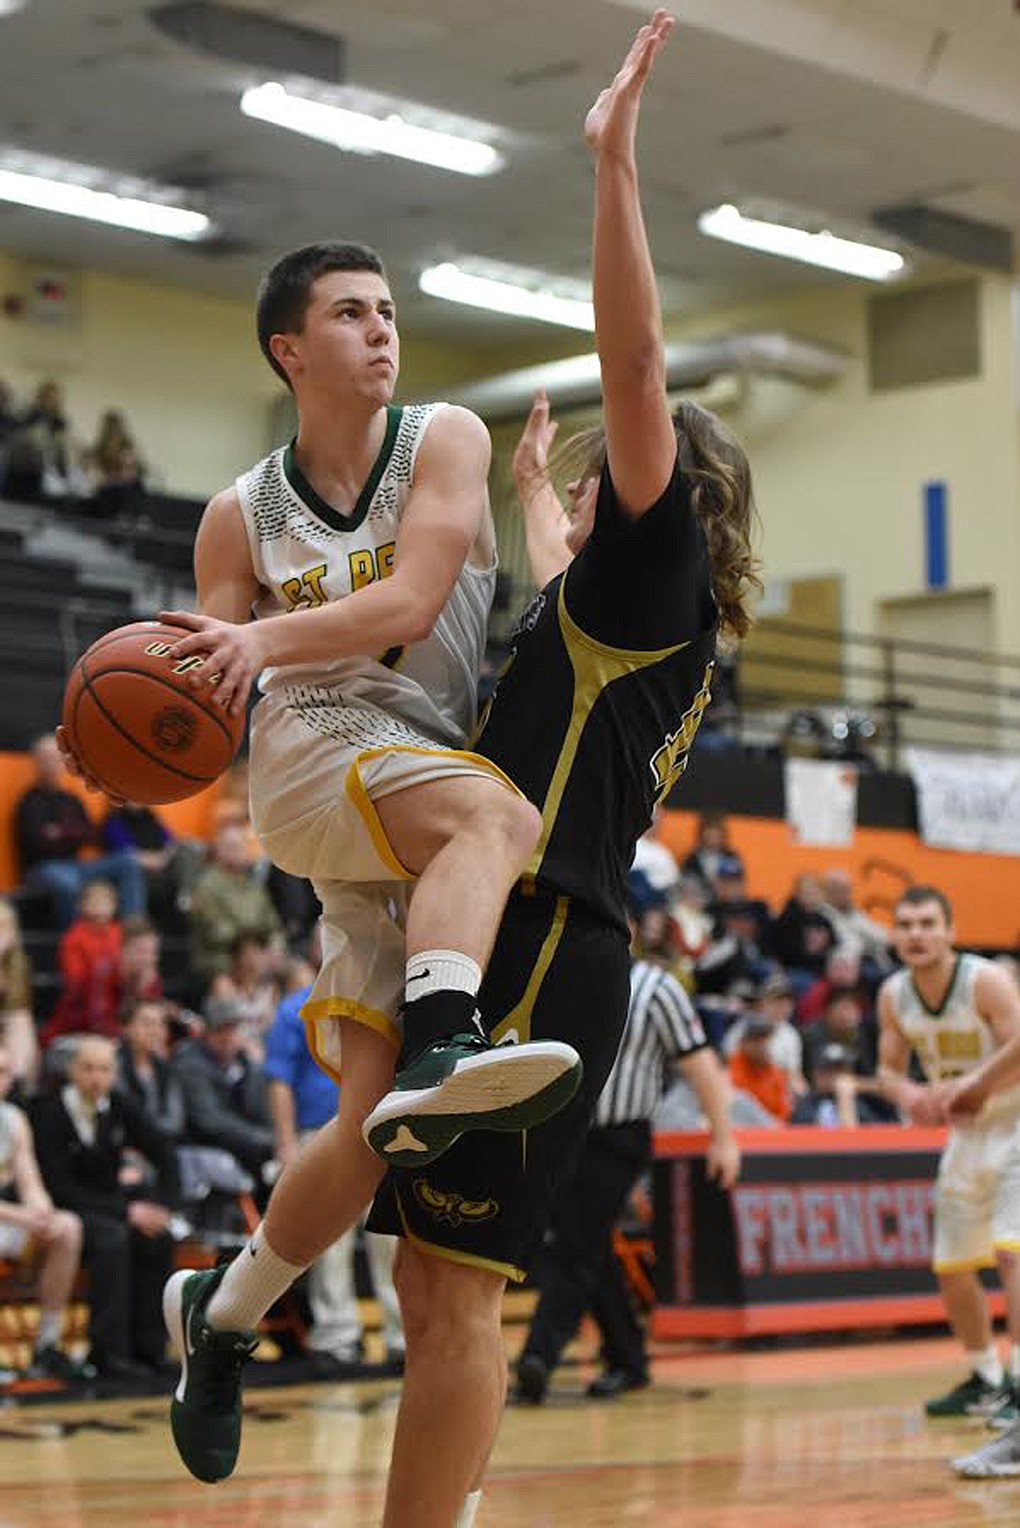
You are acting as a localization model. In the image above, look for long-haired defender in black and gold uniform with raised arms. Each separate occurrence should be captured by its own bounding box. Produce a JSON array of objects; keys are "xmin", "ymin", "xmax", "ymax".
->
[{"xmin": 370, "ymin": 11, "xmax": 756, "ymax": 1528}]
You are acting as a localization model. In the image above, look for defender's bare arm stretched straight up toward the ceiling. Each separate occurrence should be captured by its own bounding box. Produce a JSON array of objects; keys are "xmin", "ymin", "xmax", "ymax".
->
[{"xmin": 585, "ymin": 11, "xmax": 676, "ymax": 518}]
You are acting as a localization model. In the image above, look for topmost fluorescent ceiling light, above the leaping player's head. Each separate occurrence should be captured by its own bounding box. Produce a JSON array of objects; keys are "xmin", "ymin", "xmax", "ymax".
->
[{"xmin": 241, "ymin": 84, "xmax": 504, "ymax": 176}]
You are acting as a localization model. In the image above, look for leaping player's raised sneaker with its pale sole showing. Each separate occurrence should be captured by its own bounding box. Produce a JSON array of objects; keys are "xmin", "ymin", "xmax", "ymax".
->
[{"xmin": 362, "ymin": 1033, "xmax": 582, "ymax": 1167}]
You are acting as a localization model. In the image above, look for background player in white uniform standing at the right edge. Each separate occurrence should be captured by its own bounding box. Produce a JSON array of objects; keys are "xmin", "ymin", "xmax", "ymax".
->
[{"xmin": 878, "ymin": 886, "xmax": 1020, "ymax": 1416}]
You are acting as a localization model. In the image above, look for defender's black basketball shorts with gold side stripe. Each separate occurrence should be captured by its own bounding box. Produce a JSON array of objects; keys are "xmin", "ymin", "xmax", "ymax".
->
[{"xmin": 368, "ymin": 886, "xmax": 631, "ymax": 1280}]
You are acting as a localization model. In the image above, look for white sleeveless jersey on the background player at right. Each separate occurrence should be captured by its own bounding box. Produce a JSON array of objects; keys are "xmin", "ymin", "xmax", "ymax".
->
[{"xmin": 889, "ymin": 955, "xmax": 1020, "ymax": 1120}]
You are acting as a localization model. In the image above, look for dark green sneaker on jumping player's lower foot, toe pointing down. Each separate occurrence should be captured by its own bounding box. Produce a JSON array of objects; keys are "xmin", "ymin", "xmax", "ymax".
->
[{"xmin": 163, "ymin": 1268, "xmax": 258, "ymax": 1484}]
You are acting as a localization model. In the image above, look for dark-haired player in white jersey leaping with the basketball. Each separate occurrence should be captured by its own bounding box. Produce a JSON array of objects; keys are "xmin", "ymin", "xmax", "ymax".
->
[{"xmin": 63, "ymin": 244, "xmax": 580, "ymax": 1479}]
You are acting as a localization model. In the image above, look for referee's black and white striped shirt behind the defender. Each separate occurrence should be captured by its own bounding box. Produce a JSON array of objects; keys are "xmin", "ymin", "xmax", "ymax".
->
[{"xmin": 594, "ymin": 960, "xmax": 709, "ymax": 1125}]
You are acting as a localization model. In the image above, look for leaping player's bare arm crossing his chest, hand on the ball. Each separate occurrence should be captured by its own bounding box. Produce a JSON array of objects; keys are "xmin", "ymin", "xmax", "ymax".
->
[{"xmin": 162, "ymin": 408, "xmax": 490, "ymax": 712}]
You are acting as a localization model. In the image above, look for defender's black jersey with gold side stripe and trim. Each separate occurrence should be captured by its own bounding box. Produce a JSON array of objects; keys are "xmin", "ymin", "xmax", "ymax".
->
[{"xmin": 475, "ymin": 466, "xmax": 716, "ymax": 923}]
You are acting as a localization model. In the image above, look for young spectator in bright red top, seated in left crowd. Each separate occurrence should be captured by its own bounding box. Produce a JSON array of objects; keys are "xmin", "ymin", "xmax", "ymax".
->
[{"xmin": 41, "ymin": 880, "xmax": 122, "ymax": 1047}]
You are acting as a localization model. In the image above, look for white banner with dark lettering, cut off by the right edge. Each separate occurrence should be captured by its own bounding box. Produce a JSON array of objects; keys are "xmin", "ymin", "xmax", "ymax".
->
[{"xmin": 904, "ymin": 749, "xmax": 1020, "ymax": 854}]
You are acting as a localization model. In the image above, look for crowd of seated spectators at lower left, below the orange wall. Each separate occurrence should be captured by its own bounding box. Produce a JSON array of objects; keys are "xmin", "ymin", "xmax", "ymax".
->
[{"xmin": 0, "ymin": 736, "xmax": 403, "ymax": 1384}]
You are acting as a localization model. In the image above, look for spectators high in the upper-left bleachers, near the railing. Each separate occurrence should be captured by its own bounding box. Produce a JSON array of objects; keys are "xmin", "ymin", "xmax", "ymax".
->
[{"xmin": 0, "ymin": 380, "xmax": 145, "ymax": 518}]
